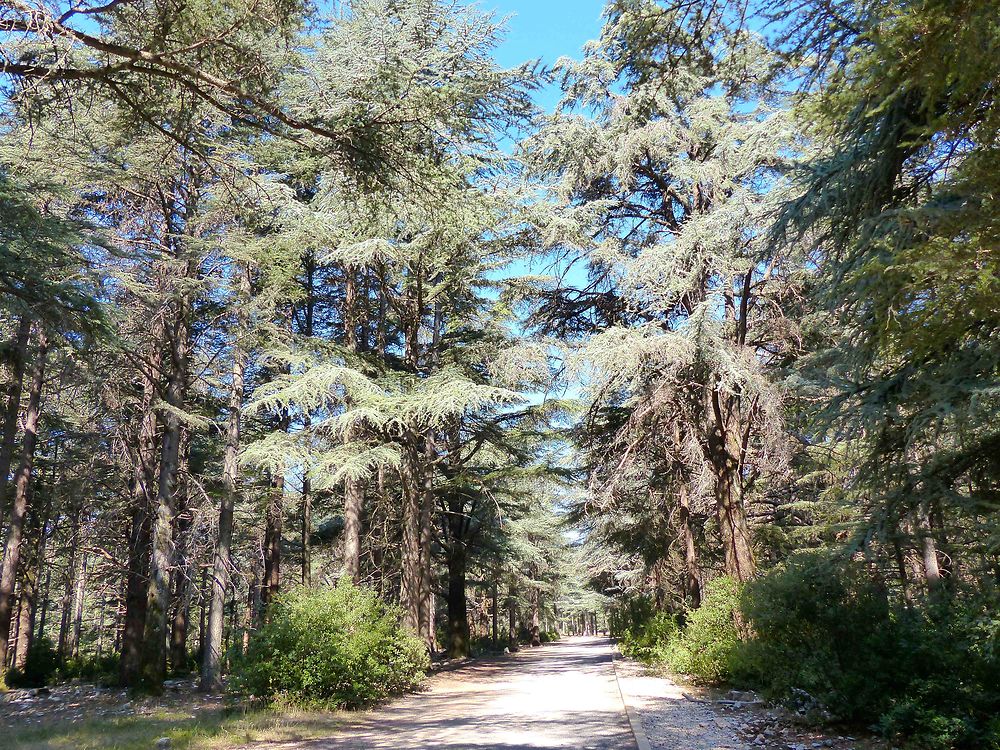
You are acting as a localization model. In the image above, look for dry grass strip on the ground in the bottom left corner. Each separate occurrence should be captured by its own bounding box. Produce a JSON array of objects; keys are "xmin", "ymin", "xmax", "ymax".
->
[{"xmin": 3, "ymin": 708, "xmax": 342, "ymax": 750}]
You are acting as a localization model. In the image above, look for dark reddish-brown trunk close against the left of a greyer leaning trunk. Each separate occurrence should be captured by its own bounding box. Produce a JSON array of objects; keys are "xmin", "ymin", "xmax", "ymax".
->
[{"xmin": 118, "ymin": 314, "xmax": 163, "ymax": 687}]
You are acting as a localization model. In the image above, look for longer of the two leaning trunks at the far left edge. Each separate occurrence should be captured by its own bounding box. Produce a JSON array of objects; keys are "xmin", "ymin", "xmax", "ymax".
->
[{"xmin": 0, "ymin": 325, "xmax": 48, "ymax": 682}]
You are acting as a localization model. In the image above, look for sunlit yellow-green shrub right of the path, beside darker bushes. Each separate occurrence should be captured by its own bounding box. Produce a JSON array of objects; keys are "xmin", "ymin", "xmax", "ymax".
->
[{"xmin": 663, "ymin": 576, "xmax": 740, "ymax": 683}]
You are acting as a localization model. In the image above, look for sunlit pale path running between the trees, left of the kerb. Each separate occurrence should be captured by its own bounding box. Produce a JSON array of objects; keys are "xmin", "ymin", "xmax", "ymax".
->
[{"xmin": 268, "ymin": 638, "xmax": 636, "ymax": 750}]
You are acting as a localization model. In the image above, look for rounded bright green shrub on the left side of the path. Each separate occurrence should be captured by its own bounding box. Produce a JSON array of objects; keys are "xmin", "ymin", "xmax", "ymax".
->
[{"xmin": 233, "ymin": 582, "xmax": 428, "ymax": 708}]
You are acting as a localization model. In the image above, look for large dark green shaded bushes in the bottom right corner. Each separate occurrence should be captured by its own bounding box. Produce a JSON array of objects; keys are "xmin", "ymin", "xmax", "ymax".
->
[{"xmin": 733, "ymin": 553, "xmax": 1000, "ymax": 750}]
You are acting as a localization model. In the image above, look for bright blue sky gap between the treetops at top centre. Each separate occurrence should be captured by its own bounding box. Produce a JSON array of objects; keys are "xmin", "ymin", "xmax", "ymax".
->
[{"xmin": 477, "ymin": 0, "xmax": 605, "ymax": 112}]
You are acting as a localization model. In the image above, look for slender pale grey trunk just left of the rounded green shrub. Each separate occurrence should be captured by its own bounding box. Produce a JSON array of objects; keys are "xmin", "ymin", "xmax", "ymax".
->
[{"xmin": 199, "ymin": 268, "xmax": 250, "ymax": 692}]
